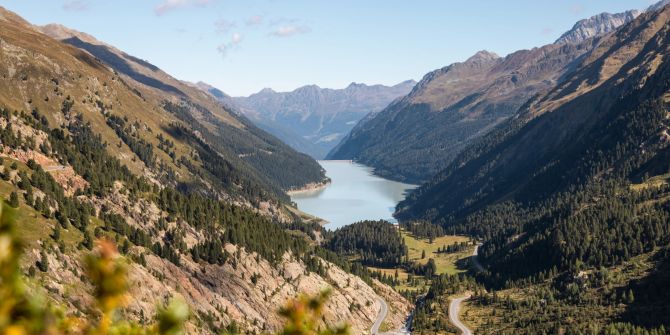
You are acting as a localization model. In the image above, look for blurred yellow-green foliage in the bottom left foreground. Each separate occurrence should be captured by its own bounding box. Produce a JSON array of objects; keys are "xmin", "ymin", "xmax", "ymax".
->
[{"xmin": 0, "ymin": 204, "xmax": 349, "ymax": 335}]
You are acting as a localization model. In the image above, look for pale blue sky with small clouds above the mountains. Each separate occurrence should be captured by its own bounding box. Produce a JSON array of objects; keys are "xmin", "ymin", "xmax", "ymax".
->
[{"xmin": 0, "ymin": 0, "xmax": 652, "ymax": 95}]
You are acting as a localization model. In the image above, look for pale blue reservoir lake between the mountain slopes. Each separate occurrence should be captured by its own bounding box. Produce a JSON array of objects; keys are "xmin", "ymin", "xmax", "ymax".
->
[{"xmin": 291, "ymin": 161, "xmax": 416, "ymax": 230}]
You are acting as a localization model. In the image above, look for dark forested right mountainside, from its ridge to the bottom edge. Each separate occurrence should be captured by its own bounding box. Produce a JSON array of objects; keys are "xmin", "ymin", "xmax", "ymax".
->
[{"xmin": 397, "ymin": 7, "xmax": 670, "ymax": 335}]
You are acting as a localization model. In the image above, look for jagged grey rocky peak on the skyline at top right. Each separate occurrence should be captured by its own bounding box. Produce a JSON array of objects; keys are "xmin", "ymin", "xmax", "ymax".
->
[{"xmin": 554, "ymin": 10, "xmax": 640, "ymax": 43}]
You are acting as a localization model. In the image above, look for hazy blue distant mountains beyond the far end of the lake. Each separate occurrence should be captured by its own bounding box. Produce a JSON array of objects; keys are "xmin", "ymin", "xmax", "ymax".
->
[{"xmin": 227, "ymin": 80, "xmax": 416, "ymax": 159}]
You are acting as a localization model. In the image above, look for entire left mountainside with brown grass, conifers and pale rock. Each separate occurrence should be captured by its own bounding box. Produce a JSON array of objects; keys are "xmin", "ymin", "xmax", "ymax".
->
[{"xmin": 0, "ymin": 9, "xmax": 410, "ymax": 334}]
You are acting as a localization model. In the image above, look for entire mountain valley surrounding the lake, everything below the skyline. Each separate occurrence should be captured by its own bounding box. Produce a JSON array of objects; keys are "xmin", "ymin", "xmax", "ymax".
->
[{"xmin": 0, "ymin": 1, "xmax": 670, "ymax": 335}]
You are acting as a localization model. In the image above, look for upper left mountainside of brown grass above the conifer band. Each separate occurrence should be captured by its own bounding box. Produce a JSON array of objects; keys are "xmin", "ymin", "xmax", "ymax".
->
[{"xmin": 0, "ymin": 9, "xmax": 325, "ymax": 210}]
